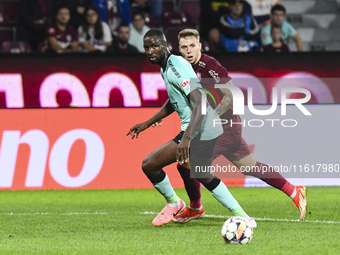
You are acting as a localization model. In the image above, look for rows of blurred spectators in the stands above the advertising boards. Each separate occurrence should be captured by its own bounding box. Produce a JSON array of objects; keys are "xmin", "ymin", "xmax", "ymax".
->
[{"xmin": 0, "ymin": 0, "xmax": 340, "ymax": 53}]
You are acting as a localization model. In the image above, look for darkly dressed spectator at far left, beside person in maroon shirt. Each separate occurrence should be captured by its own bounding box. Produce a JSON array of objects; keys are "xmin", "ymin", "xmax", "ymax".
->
[{"xmin": 17, "ymin": 0, "xmax": 60, "ymax": 51}]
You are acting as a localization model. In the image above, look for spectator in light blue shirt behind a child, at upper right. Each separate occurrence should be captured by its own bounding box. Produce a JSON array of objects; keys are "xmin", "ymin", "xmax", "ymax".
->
[{"xmin": 261, "ymin": 5, "xmax": 302, "ymax": 51}]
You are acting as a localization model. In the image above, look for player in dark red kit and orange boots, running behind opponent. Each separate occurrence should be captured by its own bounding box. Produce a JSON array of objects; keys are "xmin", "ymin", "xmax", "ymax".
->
[{"xmin": 173, "ymin": 29, "xmax": 307, "ymax": 223}]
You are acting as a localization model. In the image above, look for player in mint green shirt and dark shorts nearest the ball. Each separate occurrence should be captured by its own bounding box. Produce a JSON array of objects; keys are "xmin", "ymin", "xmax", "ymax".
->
[{"xmin": 126, "ymin": 29, "xmax": 256, "ymax": 227}]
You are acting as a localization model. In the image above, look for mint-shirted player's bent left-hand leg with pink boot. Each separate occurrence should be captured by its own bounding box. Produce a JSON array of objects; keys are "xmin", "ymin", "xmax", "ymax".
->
[{"xmin": 142, "ymin": 137, "xmax": 185, "ymax": 226}]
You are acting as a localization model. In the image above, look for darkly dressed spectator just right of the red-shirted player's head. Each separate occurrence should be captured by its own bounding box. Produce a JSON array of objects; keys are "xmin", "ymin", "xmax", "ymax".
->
[{"xmin": 199, "ymin": 0, "xmax": 229, "ymax": 45}]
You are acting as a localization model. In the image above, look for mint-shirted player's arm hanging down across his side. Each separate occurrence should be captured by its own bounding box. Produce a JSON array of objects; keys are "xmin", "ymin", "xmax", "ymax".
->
[{"xmin": 176, "ymin": 89, "xmax": 204, "ymax": 164}]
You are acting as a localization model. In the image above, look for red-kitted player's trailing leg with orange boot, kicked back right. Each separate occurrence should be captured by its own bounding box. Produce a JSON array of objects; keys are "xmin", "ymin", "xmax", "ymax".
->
[{"xmin": 232, "ymin": 150, "xmax": 307, "ymax": 220}]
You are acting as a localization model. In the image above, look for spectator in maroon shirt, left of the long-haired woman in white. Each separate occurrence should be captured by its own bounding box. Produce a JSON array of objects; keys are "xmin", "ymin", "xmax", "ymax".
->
[{"xmin": 46, "ymin": 7, "xmax": 78, "ymax": 53}]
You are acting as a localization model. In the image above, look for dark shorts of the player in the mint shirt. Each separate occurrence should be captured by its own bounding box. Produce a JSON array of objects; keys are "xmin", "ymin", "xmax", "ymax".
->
[{"xmin": 172, "ymin": 131, "xmax": 217, "ymax": 158}]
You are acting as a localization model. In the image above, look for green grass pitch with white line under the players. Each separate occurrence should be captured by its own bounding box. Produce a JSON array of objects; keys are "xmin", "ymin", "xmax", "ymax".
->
[{"xmin": 0, "ymin": 187, "xmax": 340, "ymax": 255}]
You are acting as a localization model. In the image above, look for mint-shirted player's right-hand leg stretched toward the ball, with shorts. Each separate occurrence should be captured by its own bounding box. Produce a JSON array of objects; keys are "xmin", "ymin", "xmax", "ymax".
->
[{"xmin": 190, "ymin": 136, "xmax": 256, "ymax": 227}]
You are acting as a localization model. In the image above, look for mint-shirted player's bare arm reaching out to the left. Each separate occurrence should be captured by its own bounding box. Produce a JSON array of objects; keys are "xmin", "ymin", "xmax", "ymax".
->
[{"xmin": 126, "ymin": 99, "xmax": 174, "ymax": 139}]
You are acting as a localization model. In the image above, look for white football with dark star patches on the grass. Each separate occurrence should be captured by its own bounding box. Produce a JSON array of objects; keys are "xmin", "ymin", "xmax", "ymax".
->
[{"xmin": 222, "ymin": 216, "xmax": 253, "ymax": 244}]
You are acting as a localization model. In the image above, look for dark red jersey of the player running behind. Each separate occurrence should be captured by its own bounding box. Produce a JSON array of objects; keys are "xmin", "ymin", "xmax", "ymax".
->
[{"xmin": 193, "ymin": 53, "xmax": 233, "ymax": 120}]
